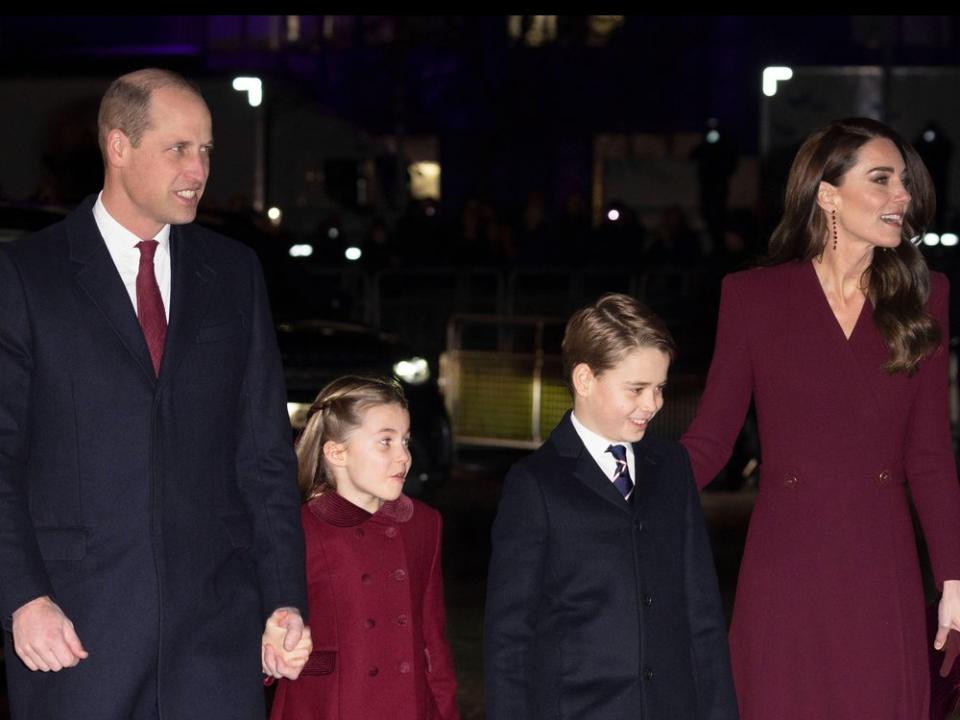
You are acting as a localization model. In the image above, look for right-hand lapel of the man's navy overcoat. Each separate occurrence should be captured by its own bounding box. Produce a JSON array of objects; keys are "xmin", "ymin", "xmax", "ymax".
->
[{"xmin": 158, "ymin": 225, "xmax": 217, "ymax": 384}]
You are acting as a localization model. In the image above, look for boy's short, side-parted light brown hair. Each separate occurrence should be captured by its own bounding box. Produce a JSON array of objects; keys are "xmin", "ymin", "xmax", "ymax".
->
[{"xmin": 561, "ymin": 293, "xmax": 677, "ymax": 397}]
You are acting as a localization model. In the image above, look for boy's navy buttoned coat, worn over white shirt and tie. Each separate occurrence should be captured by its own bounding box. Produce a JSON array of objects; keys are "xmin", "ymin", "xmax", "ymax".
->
[{"xmin": 484, "ymin": 413, "xmax": 737, "ymax": 720}]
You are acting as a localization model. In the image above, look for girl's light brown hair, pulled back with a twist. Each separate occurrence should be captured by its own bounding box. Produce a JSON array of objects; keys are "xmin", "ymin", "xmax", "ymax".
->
[{"xmin": 296, "ymin": 375, "xmax": 407, "ymax": 501}]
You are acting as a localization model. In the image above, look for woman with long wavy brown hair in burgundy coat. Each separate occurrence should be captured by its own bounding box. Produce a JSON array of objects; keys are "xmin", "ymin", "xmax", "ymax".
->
[{"xmin": 682, "ymin": 119, "xmax": 960, "ymax": 720}]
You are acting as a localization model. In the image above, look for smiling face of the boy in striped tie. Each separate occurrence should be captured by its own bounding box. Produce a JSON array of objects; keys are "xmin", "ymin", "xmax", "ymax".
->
[{"xmin": 573, "ymin": 347, "xmax": 670, "ymax": 443}]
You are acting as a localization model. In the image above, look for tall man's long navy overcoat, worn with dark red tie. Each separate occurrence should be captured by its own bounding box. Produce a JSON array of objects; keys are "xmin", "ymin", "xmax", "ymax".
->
[{"xmin": 0, "ymin": 197, "xmax": 306, "ymax": 720}]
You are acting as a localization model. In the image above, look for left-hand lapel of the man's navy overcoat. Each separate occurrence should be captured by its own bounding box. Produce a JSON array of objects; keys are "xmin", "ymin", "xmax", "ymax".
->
[{"xmin": 65, "ymin": 196, "xmax": 156, "ymax": 383}]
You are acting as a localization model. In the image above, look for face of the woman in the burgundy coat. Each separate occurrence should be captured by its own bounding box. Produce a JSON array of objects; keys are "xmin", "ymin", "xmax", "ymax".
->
[{"xmin": 820, "ymin": 138, "xmax": 910, "ymax": 248}]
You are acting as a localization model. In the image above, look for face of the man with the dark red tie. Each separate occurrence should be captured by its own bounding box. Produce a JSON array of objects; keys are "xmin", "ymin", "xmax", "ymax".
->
[{"xmin": 117, "ymin": 87, "xmax": 213, "ymax": 237}]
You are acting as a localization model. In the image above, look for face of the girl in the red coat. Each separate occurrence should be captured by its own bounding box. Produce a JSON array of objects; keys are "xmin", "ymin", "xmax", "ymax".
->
[{"xmin": 324, "ymin": 404, "xmax": 410, "ymax": 513}]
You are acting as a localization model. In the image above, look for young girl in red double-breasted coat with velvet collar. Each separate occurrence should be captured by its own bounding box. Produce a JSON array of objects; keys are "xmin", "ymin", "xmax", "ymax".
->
[{"xmin": 270, "ymin": 376, "xmax": 460, "ymax": 720}]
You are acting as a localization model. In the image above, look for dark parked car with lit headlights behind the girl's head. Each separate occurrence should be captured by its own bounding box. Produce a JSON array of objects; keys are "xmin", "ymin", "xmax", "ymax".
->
[{"xmin": 277, "ymin": 319, "xmax": 453, "ymax": 496}]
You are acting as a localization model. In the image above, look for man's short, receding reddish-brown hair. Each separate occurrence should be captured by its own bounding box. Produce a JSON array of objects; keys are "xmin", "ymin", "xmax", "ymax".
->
[{"xmin": 97, "ymin": 68, "xmax": 203, "ymax": 162}]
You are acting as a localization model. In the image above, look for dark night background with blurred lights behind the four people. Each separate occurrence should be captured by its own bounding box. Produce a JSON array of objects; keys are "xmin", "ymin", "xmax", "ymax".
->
[{"xmin": 0, "ymin": 15, "xmax": 960, "ymax": 718}]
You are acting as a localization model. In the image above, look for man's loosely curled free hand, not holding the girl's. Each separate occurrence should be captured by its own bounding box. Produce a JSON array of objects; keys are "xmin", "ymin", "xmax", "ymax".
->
[{"xmin": 13, "ymin": 595, "xmax": 87, "ymax": 672}]
